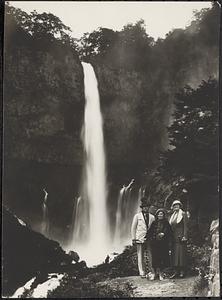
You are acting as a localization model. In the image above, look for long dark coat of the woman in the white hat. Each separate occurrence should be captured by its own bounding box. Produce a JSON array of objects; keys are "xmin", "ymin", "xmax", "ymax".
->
[{"xmin": 171, "ymin": 211, "xmax": 187, "ymax": 267}]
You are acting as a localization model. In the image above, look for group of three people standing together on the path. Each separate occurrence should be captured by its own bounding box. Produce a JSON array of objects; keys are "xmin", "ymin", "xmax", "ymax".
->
[{"xmin": 131, "ymin": 197, "xmax": 187, "ymax": 280}]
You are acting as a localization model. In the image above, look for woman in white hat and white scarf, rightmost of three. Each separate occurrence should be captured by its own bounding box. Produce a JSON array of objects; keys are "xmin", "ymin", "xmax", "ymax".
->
[{"xmin": 169, "ymin": 200, "xmax": 187, "ymax": 279}]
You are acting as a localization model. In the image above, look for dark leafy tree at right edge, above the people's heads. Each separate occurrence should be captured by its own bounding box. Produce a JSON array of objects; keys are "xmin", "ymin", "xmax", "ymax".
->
[{"xmin": 157, "ymin": 79, "xmax": 218, "ymax": 219}]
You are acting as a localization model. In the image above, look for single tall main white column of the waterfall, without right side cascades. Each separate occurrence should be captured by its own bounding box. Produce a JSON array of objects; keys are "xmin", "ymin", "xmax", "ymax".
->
[{"xmin": 69, "ymin": 63, "xmax": 110, "ymax": 265}]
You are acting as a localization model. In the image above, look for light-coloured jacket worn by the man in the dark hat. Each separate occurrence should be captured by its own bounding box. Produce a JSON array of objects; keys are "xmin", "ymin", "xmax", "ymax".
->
[{"xmin": 131, "ymin": 212, "xmax": 155, "ymax": 244}]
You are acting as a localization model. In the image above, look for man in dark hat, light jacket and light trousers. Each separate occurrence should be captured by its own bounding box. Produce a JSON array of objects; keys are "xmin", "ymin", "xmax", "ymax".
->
[{"xmin": 131, "ymin": 197, "xmax": 155, "ymax": 280}]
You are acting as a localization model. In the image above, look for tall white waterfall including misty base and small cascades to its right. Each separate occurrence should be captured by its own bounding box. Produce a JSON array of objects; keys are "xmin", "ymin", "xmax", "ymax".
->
[{"xmin": 66, "ymin": 62, "xmax": 141, "ymax": 266}]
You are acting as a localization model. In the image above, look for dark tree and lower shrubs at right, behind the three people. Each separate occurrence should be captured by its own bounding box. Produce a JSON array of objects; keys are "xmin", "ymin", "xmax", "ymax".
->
[{"xmin": 142, "ymin": 79, "xmax": 219, "ymax": 243}]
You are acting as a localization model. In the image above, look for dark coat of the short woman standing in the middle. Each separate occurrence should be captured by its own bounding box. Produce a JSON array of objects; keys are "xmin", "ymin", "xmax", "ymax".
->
[{"xmin": 149, "ymin": 219, "xmax": 172, "ymax": 269}]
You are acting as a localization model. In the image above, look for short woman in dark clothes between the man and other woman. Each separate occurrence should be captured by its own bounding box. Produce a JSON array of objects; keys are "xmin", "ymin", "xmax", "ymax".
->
[{"xmin": 149, "ymin": 208, "xmax": 172, "ymax": 280}]
